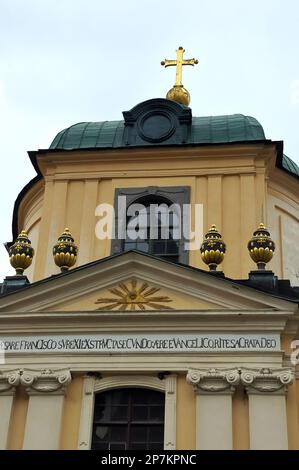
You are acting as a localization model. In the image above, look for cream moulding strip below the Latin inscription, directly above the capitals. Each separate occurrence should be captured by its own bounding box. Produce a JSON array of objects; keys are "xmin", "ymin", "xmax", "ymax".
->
[{"xmin": 2, "ymin": 351, "xmax": 282, "ymax": 375}]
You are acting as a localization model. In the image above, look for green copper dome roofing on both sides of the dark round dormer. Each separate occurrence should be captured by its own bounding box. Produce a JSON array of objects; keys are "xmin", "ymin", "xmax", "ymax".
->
[{"xmin": 50, "ymin": 114, "xmax": 265, "ymax": 150}]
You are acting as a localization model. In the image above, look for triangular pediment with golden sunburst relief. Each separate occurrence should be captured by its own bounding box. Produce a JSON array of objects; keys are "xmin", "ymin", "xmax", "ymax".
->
[{"xmin": 0, "ymin": 252, "xmax": 296, "ymax": 313}]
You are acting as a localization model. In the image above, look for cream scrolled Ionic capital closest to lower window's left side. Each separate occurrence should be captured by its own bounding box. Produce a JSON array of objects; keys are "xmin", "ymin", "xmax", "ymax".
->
[{"xmin": 20, "ymin": 369, "xmax": 72, "ymax": 395}]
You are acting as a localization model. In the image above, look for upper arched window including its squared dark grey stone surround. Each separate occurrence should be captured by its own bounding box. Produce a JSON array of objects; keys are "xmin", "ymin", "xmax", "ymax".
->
[{"xmin": 111, "ymin": 186, "xmax": 190, "ymax": 264}]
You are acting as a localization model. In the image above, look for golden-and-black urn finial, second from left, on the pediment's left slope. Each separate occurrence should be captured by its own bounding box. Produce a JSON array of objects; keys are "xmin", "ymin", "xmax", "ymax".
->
[{"xmin": 53, "ymin": 228, "xmax": 78, "ymax": 272}]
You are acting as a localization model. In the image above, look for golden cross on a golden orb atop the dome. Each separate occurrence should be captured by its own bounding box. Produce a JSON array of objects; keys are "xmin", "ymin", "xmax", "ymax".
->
[{"xmin": 161, "ymin": 47, "xmax": 198, "ymax": 106}]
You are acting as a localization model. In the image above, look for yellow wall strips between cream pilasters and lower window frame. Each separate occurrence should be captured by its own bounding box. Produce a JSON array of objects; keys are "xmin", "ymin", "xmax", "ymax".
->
[{"xmin": 7, "ymin": 370, "xmax": 299, "ymax": 450}]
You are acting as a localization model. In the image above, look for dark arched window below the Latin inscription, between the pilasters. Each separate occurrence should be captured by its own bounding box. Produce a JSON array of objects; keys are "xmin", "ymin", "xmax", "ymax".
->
[{"xmin": 91, "ymin": 388, "xmax": 165, "ymax": 450}]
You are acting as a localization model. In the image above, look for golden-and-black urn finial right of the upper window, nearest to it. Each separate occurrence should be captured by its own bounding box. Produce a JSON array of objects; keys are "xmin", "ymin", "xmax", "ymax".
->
[{"xmin": 200, "ymin": 225, "xmax": 226, "ymax": 271}]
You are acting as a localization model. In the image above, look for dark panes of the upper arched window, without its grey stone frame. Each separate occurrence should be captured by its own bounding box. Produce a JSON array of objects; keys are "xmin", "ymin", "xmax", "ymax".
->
[{"xmin": 123, "ymin": 197, "xmax": 180, "ymax": 262}]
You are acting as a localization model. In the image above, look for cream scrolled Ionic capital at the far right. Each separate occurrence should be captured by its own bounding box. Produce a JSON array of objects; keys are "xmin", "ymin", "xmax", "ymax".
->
[{"xmin": 240, "ymin": 367, "xmax": 294, "ymax": 395}]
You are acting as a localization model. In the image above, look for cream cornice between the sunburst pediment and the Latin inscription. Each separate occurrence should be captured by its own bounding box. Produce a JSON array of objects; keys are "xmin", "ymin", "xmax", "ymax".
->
[{"xmin": 1, "ymin": 309, "xmax": 292, "ymax": 335}]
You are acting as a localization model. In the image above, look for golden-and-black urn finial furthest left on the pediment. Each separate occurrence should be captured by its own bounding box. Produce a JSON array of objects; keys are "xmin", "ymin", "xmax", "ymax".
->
[{"xmin": 8, "ymin": 230, "xmax": 34, "ymax": 276}]
